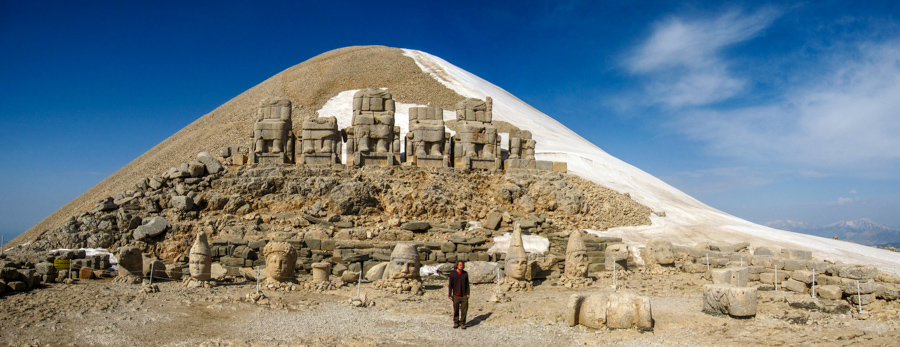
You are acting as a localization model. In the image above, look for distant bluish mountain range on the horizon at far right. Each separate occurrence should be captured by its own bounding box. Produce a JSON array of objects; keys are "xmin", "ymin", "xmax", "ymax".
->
[{"xmin": 763, "ymin": 218, "xmax": 900, "ymax": 247}]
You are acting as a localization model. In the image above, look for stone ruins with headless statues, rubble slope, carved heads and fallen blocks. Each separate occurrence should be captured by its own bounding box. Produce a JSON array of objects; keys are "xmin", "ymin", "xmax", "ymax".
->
[{"xmin": 0, "ymin": 88, "xmax": 900, "ymax": 344}]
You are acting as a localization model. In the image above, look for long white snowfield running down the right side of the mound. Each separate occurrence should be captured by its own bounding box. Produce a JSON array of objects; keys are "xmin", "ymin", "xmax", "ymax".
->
[{"xmin": 400, "ymin": 49, "xmax": 900, "ymax": 275}]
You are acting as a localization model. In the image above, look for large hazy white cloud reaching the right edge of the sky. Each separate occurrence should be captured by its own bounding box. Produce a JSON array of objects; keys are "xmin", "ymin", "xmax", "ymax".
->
[{"xmin": 670, "ymin": 40, "xmax": 900, "ymax": 175}]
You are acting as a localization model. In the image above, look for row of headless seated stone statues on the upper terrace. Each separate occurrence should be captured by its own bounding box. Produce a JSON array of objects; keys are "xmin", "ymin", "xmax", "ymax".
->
[{"xmin": 239, "ymin": 88, "xmax": 566, "ymax": 172}]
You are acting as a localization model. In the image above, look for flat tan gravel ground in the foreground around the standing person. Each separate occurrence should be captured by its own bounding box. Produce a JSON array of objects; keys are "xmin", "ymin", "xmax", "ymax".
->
[{"xmin": 0, "ymin": 272, "xmax": 900, "ymax": 346}]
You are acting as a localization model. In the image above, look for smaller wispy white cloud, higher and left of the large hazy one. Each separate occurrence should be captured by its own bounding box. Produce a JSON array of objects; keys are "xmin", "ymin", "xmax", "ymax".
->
[{"xmin": 625, "ymin": 8, "xmax": 780, "ymax": 107}]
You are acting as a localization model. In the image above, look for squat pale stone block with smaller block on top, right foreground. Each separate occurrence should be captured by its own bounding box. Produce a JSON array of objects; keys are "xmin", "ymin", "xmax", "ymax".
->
[{"xmin": 703, "ymin": 284, "xmax": 757, "ymax": 317}]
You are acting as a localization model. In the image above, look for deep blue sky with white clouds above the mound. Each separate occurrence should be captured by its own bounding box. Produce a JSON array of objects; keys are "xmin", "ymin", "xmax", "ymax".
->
[{"xmin": 0, "ymin": 0, "xmax": 900, "ymax": 240}]
